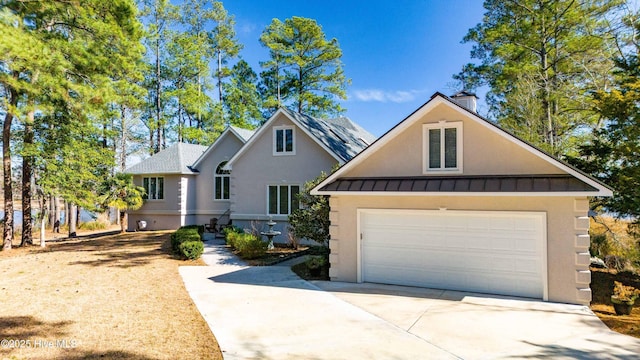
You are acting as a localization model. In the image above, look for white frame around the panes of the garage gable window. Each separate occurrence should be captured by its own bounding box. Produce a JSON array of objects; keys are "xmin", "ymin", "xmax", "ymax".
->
[{"xmin": 422, "ymin": 120, "xmax": 464, "ymax": 175}]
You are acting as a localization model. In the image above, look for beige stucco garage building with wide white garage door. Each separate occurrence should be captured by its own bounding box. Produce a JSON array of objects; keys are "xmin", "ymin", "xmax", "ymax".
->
[{"xmin": 312, "ymin": 93, "xmax": 612, "ymax": 304}]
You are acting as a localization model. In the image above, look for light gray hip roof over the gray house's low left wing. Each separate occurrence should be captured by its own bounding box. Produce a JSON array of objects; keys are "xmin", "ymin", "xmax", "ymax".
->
[{"xmin": 125, "ymin": 142, "xmax": 207, "ymax": 175}]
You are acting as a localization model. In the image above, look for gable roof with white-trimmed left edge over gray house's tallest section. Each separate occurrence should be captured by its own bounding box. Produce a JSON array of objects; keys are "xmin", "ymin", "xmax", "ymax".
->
[{"xmin": 227, "ymin": 107, "xmax": 376, "ymax": 166}]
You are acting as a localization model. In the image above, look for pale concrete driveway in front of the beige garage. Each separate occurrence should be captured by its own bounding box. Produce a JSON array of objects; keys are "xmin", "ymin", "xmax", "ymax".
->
[{"xmin": 180, "ymin": 241, "xmax": 640, "ymax": 359}]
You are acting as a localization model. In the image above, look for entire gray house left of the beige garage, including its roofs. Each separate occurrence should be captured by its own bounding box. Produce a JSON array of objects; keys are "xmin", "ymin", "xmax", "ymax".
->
[{"xmin": 127, "ymin": 108, "xmax": 375, "ymax": 238}]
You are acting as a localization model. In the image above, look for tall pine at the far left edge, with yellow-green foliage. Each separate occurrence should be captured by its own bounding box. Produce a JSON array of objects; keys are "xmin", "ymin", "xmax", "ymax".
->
[{"xmin": 0, "ymin": 0, "xmax": 141, "ymax": 244}]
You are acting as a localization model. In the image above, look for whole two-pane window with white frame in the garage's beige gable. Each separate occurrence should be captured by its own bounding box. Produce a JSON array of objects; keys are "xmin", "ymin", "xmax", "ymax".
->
[{"xmin": 423, "ymin": 121, "xmax": 462, "ymax": 173}]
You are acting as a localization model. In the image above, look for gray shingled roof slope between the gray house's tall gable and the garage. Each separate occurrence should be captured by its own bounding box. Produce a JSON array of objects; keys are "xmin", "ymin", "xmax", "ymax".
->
[{"xmin": 282, "ymin": 108, "xmax": 376, "ymax": 162}]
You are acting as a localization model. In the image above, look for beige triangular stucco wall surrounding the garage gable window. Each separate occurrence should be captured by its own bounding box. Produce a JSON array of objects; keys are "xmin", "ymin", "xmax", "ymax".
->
[{"xmin": 348, "ymin": 104, "xmax": 564, "ymax": 177}]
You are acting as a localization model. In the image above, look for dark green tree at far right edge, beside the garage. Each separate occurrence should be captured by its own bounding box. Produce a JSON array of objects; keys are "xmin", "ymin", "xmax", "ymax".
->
[{"xmin": 569, "ymin": 9, "xmax": 640, "ymax": 225}]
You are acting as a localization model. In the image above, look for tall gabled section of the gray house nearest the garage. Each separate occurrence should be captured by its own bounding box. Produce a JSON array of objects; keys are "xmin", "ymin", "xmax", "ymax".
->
[{"xmin": 227, "ymin": 108, "xmax": 375, "ymax": 238}]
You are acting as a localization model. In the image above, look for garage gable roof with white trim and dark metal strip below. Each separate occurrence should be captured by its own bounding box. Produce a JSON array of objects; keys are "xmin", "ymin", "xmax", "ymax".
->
[{"xmin": 311, "ymin": 92, "xmax": 612, "ymax": 196}]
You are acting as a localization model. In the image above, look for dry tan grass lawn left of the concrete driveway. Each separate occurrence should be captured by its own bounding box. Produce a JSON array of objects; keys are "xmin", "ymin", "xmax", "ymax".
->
[{"xmin": 0, "ymin": 232, "xmax": 222, "ymax": 359}]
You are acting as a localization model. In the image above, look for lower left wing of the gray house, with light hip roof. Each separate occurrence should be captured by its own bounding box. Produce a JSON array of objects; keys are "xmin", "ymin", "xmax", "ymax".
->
[{"xmin": 126, "ymin": 126, "xmax": 253, "ymax": 231}]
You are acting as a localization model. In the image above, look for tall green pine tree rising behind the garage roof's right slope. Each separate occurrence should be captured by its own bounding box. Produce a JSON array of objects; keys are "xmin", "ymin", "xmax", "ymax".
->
[{"xmin": 455, "ymin": 0, "xmax": 620, "ymax": 155}]
